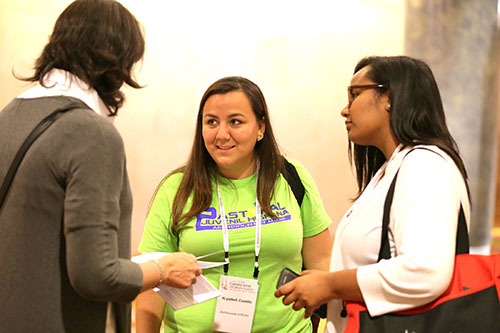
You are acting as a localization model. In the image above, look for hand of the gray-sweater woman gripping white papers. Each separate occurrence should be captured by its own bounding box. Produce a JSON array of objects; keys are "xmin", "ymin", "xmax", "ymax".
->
[{"xmin": 158, "ymin": 252, "xmax": 201, "ymax": 289}]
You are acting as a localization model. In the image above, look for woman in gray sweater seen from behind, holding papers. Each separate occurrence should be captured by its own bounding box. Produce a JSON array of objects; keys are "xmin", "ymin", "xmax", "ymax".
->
[{"xmin": 0, "ymin": 0, "xmax": 200, "ymax": 332}]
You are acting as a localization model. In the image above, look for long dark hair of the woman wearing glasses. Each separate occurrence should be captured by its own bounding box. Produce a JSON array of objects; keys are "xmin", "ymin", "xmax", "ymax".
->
[{"xmin": 349, "ymin": 56, "xmax": 468, "ymax": 197}]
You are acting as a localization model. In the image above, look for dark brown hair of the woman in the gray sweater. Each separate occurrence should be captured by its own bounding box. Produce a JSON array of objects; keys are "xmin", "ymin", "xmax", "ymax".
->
[{"xmin": 21, "ymin": 0, "xmax": 145, "ymax": 116}]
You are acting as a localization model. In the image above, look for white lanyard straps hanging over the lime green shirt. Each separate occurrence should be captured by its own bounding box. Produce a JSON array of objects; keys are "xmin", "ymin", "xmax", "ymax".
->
[{"xmin": 216, "ymin": 176, "xmax": 262, "ymax": 278}]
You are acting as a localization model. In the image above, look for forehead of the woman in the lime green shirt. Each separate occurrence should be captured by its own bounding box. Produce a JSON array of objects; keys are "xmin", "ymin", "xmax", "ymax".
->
[{"xmin": 203, "ymin": 90, "xmax": 253, "ymax": 114}]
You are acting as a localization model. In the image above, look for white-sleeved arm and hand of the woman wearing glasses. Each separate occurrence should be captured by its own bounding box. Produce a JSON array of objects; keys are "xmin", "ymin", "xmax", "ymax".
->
[{"xmin": 276, "ymin": 151, "xmax": 466, "ymax": 315}]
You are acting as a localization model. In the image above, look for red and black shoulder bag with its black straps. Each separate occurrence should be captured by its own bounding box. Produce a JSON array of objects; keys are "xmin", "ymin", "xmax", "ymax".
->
[{"xmin": 344, "ymin": 148, "xmax": 500, "ymax": 333}]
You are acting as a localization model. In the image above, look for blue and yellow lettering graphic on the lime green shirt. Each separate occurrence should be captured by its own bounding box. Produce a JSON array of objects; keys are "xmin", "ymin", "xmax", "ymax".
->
[{"xmin": 196, "ymin": 202, "xmax": 292, "ymax": 231}]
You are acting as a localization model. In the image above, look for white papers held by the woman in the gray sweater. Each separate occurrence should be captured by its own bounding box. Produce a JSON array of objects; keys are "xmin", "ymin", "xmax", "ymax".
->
[{"xmin": 132, "ymin": 252, "xmax": 224, "ymax": 310}]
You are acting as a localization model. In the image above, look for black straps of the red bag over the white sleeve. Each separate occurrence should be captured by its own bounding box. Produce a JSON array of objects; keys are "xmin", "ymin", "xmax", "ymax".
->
[{"xmin": 377, "ymin": 148, "xmax": 469, "ymax": 262}]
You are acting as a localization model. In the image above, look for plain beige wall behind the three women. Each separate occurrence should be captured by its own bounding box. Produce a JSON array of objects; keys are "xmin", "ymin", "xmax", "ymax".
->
[{"xmin": 0, "ymin": 0, "xmax": 404, "ymax": 249}]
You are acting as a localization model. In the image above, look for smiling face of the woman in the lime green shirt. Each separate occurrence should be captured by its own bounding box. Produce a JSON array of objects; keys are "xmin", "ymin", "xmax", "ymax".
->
[{"xmin": 202, "ymin": 91, "xmax": 265, "ymax": 179}]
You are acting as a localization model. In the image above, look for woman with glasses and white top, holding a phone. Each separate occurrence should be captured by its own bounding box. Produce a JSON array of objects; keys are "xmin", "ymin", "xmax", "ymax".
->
[{"xmin": 276, "ymin": 56, "xmax": 470, "ymax": 332}]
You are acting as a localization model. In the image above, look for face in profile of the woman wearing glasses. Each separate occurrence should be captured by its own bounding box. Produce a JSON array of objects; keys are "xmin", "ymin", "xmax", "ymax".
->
[{"xmin": 341, "ymin": 66, "xmax": 392, "ymax": 152}]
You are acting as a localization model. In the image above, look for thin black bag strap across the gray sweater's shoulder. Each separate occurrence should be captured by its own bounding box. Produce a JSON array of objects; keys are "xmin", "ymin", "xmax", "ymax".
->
[{"xmin": 0, "ymin": 103, "xmax": 86, "ymax": 209}]
